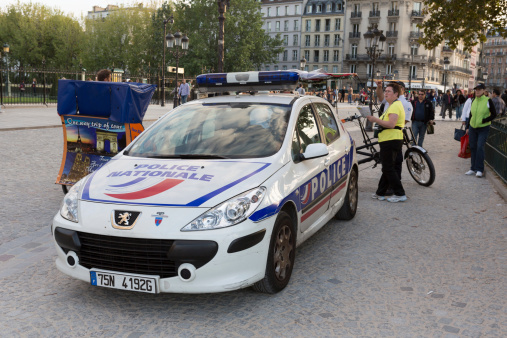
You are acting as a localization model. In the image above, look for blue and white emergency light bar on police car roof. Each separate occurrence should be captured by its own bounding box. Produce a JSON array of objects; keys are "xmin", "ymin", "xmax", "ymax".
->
[{"xmin": 196, "ymin": 71, "xmax": 299, "ymax": 93}]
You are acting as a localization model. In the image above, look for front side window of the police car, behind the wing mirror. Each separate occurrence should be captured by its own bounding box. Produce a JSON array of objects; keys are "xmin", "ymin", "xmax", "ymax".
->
[{"xmin": 292, "ymin": 105, "xmax": 321, "ymax": 161}]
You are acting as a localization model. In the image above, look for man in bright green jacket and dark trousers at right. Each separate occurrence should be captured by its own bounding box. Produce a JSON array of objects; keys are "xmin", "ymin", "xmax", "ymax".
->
[{"xmin": 465, "ymin": 83, "xmax": 496, "ymax": 177}]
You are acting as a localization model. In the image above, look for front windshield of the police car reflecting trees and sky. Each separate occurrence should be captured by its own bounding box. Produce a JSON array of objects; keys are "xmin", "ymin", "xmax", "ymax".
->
[{"xmin": 128, "ymin": 103, "xmax": 291, "ymax": 158}]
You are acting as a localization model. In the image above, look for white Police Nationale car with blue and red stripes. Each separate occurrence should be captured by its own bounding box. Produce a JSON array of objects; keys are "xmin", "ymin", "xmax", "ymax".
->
[{"xmin": 52, "ymin": 72, "xmax": 358, "ymax": 293}]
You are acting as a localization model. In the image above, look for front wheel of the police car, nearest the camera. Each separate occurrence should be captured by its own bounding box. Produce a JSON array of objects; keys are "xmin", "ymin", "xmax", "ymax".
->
[{"xmin": 252, "ymin": 211, "xmax": 296, "ymax": 294}]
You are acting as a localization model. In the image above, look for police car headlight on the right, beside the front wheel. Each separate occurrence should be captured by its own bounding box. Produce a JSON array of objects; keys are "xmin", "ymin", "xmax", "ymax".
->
[{"xmin": 181, "ymin": 187, "xmax": 266, "ymax": 231}]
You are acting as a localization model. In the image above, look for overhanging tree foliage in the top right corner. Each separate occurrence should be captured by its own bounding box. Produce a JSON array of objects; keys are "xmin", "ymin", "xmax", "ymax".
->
[{"xmin": 420, "ymin": 0, "xmax": 507, "ymax": 51}]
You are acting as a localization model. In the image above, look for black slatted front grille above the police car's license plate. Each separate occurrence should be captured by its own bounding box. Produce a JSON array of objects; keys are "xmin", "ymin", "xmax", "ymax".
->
[{"xmin": 78, "ymin": 232, "xmax": 177, "ymax": 278}]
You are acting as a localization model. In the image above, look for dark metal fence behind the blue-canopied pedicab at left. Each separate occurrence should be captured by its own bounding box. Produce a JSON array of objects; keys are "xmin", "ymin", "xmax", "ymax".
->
[{"xmin": 0, "ymin": 67, "xmax": 195, "ymax": 105}]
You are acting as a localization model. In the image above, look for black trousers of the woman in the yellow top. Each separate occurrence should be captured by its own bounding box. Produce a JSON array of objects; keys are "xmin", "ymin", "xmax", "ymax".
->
[{"xmin": 376, "ymin": 140, "xmax": 405, "ymax": 196}]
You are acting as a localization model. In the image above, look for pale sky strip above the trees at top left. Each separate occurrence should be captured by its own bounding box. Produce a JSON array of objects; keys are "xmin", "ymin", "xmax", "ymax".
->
[{"xmin": 0, "ymin": 0, "xmax": 161, "ymax": 19}]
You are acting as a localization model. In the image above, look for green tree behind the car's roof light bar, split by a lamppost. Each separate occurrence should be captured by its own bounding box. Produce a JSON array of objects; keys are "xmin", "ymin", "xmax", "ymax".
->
[{"xmin": 170, "ymin": 0, "xmax": 283, "ymax": 75}]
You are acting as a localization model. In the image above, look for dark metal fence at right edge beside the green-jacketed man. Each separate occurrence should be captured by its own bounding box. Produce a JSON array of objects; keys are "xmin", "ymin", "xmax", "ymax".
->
[{"xmin": 485, "ymin": 117, "xmax": 507, "ymax": 184}]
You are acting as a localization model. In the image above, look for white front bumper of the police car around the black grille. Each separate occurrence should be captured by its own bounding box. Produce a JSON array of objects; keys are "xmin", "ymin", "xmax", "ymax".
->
[{"xmin": 53, "ymin": 214, "xmax": 275, "ymax": 293}]
